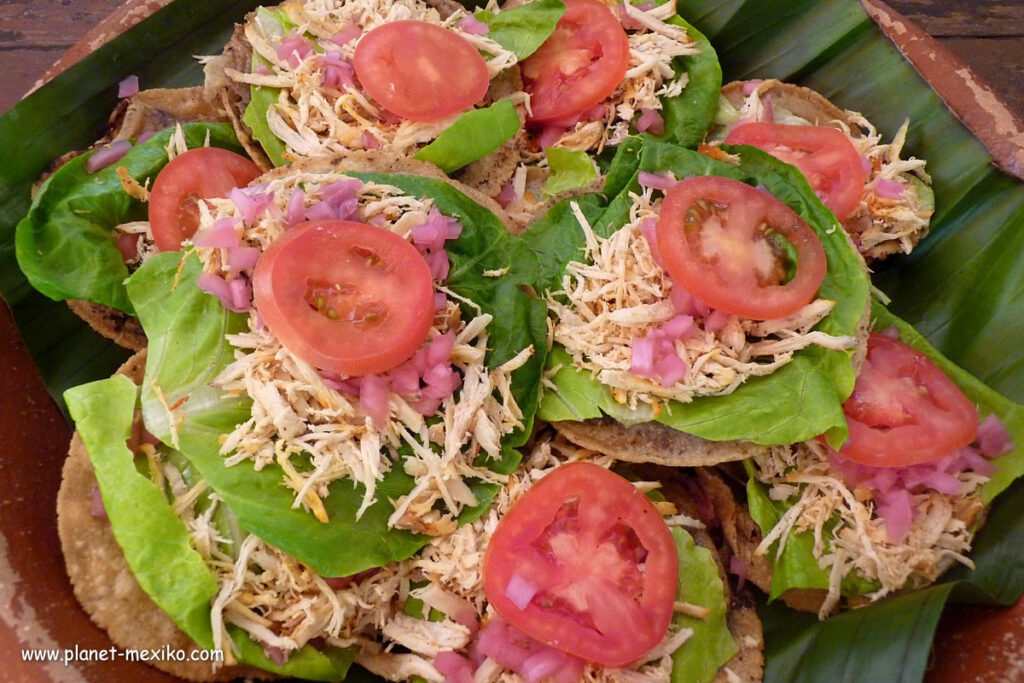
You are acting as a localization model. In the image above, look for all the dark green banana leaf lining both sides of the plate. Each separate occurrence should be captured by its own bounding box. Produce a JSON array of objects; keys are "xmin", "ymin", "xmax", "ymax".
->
[{"xmin": 0, "ymin": 0, "xmax": 1024, "ymax": 682}]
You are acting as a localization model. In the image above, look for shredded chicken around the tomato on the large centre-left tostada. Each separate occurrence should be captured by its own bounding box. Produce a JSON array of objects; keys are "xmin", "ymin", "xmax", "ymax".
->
[{"xmin": 190, "ymin": 172, "xmax": 532, "ymax": 536}]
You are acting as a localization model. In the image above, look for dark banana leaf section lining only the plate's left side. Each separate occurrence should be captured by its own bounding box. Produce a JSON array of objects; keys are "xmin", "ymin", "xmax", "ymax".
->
[{"xmin": 0, "ymin": 0, "xmax": 259, "ymax": 407}]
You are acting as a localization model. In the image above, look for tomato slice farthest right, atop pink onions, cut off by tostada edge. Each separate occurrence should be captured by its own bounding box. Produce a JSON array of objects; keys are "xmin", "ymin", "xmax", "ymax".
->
[{"xmin": 840, "ymin": 334, "xmax": 978, "ymax": 467}]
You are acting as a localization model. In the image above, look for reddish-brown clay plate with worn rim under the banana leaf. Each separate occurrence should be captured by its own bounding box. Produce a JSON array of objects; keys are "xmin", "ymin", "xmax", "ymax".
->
[{"xmin": 0, "ymin": 0, "xmax": 1024, "ymax": 683}]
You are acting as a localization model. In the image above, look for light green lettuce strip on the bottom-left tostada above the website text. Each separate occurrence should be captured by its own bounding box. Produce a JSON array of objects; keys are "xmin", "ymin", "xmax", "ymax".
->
[{"xmin": 66, "ymin": 375, "xmax": 355, "ymax": 681}]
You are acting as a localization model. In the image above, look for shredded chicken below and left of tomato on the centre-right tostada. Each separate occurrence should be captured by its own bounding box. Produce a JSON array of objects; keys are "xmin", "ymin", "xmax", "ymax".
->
[{"xmin": 547, "ymin": 188, "xmax": 856, "ymax": 409}]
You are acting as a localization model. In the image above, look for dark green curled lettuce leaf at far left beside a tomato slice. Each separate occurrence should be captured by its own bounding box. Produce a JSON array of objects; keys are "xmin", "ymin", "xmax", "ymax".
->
[{"xmin": 14, "ymin": 123, "xmax": 242, "ymax": 313}]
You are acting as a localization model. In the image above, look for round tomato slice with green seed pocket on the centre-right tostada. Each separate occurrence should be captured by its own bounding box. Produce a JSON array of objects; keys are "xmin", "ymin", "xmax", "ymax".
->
[{"xmin": 656, "ymin": 176, "xmax": 827, "ymax": 321}]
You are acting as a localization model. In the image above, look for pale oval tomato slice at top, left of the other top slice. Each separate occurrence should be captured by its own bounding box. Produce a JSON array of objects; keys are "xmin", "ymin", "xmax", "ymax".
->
[{"xmin": 352, "ymin": 20, "xmax": 490, "ymax": 121}]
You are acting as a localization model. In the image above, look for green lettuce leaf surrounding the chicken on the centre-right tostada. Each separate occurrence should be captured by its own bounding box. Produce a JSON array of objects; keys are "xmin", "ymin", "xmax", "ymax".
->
[{"xmin": 523, "ymin": 137, "xmax": 868, "ymax": 444}]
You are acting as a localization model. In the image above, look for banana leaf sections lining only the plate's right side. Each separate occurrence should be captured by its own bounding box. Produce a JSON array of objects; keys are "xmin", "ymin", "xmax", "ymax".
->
[{"xmin": 680, "ymin": 0, "xmax": 1024, "ymax": 683}]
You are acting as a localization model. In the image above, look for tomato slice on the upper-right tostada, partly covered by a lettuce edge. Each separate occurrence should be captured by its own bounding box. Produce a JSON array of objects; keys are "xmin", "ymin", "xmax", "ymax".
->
[{"xmin": 725, "ymin": 122, "xmax": 867, "ymax": 222}]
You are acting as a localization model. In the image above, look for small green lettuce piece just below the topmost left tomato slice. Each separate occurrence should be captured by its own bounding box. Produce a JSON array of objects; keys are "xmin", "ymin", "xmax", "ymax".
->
[{"xmin": 416, "ymin": 99, "xmax": 520, "ymax": 173}]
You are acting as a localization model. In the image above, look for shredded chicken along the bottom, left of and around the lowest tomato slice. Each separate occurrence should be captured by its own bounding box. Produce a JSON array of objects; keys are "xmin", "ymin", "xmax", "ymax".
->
[{"xmin": 164, "ymin": 439, "xmax": 703, "ymax": 683}]
